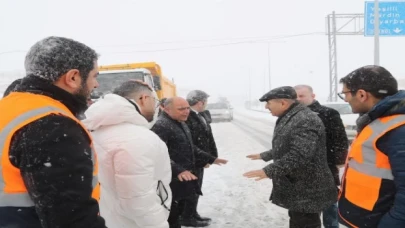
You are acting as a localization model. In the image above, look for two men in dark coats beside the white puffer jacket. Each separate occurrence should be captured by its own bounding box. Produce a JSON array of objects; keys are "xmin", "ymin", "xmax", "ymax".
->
[{"xmin": 152, "ymin": 90, "xmax": 227, "ymax": 228}]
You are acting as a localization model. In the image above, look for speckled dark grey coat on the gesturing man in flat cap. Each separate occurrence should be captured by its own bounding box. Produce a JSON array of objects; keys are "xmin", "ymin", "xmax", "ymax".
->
[{"xmin": 261, "ymin": 104, "xmax": 337, "ymax": 213}]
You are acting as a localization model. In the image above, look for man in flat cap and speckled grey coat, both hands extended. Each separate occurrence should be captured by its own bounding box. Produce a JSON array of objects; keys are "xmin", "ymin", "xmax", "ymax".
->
[{"xmin": 244, "ymin": 86, "xmax": 337, "ymax": 228}]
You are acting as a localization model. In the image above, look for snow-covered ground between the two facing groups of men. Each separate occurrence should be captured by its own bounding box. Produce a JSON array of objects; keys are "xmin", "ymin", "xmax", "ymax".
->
[{"xmin": 199, "ymin": 109, "xmax": 343, "ymax": 228}]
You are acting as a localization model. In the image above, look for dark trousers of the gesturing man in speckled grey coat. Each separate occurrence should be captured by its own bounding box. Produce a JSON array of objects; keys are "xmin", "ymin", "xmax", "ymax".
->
[{"xmin": 288, "ymin": 211, "xmax": 322, "ymax": 228}]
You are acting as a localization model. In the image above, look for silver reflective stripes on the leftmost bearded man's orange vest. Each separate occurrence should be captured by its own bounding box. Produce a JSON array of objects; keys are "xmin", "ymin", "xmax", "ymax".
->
[{"xmin": 0, "ymin": 106, "xmax": 98, "ymax": 207}]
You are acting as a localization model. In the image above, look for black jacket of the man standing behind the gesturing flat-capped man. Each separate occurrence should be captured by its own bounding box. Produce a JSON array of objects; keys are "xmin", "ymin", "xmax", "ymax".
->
[{"xmin": 308, "ymin": 101, "xmax": 349, "ymax": 186}]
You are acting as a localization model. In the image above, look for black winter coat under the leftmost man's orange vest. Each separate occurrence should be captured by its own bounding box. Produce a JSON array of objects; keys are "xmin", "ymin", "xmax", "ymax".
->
[{"xmin": 0, "ymin": 76, "xmax": 106, "ymax": 228}]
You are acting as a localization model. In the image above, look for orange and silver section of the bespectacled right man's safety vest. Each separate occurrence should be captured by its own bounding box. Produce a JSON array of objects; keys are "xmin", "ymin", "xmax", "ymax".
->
[{"xmin": 340, "ymin": 115, "xmax": 405, "ymax": 212}]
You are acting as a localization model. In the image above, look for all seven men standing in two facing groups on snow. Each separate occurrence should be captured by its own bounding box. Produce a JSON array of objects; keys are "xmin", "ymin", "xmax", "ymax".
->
[{"xmin": 0, "ymin": 34, "xmax": 405, "ymax": 228}]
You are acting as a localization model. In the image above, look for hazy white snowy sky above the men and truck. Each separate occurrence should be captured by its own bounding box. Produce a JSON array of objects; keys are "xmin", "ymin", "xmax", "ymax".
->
[{"xmin": 0, "ymin": 0, "xmax": 405, "ymax": 99}]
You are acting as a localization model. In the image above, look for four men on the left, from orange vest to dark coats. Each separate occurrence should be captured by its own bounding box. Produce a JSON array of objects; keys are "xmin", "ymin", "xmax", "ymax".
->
[{"xmin": 0, "ymin": 37, "xmax": 227, "ymax": 228}]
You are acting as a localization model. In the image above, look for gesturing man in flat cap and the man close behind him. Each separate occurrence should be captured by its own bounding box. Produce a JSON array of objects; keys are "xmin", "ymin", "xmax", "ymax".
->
[{"xmin": 245, "ymin": 85, "xmax": 348, "ymax": 228}]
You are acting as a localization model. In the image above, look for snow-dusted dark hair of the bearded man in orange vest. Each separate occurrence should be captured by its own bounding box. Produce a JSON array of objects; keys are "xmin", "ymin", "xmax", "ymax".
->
[{"xmin": 25, "ymin": 36, "xmax": 98, "ymax": 82}]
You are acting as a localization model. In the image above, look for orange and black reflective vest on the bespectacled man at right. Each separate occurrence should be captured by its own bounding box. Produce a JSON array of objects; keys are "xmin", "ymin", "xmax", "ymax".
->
[{"xmin": 339, "ymin": 115, "xmax": 405, "ymax": 227}]
